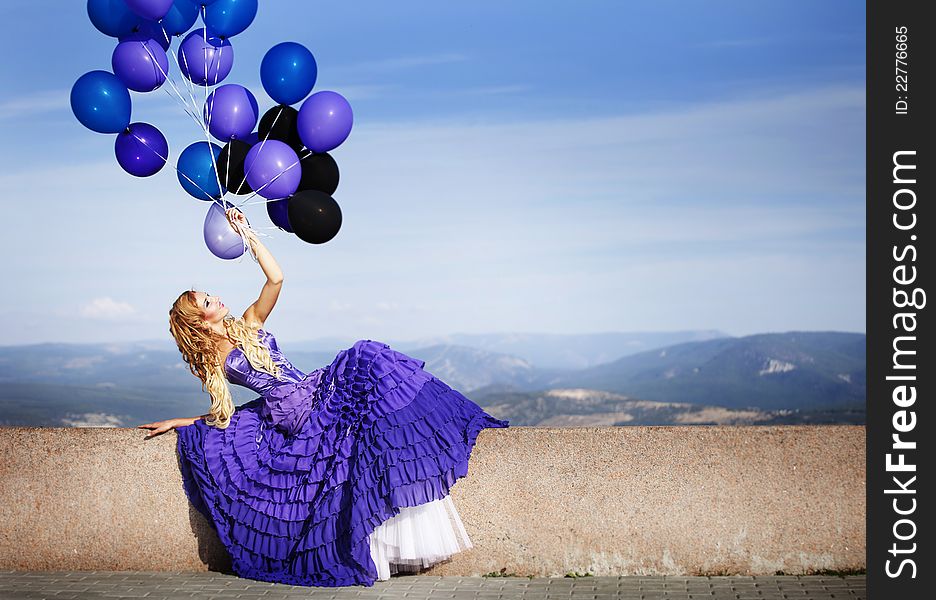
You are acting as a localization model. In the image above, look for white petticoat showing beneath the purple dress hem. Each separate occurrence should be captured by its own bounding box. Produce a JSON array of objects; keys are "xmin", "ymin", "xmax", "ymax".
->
[{"xmin": 370, "ymin": 495, "xmax": 473, "ymax": 581}]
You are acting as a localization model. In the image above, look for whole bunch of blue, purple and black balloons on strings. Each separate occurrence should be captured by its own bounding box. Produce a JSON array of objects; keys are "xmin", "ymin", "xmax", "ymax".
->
[{"xmin": 71, "ymin": 0, "xmax": 353, "ymax": 259}]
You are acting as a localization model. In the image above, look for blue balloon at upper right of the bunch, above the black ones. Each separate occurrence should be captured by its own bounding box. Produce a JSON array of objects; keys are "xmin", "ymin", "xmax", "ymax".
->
[{"xmin": 260, "ymin": 42, "xmax": 318, "ymax": 104}]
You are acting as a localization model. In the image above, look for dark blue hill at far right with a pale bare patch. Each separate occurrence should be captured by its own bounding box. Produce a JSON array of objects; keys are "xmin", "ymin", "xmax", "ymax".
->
[{"xmin": 534, "ymin": 331, "xmax": 866, "ymax": 410}]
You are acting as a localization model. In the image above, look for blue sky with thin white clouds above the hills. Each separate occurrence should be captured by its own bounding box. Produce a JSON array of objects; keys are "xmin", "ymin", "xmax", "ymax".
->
[{"xmin": 0, "ymin": 0, "xmax": 866, "ymax": 345}]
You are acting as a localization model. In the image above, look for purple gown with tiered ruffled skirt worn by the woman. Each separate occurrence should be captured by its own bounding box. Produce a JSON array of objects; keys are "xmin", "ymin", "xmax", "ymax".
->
[{"xmin": 176, "ymin": 329, "xmax": 508, "ymax": 586}]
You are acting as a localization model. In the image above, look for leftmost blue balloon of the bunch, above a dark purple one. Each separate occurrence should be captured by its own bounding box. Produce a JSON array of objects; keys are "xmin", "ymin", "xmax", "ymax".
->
[{"xmin": 71, "ymin": 71, "xmax": 130, "ymax": 133}]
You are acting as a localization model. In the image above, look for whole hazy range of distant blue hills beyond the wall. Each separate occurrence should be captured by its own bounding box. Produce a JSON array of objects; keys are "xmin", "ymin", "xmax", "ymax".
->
[{"xmin": 0, "ymin": 332, "xmax": 865, "ymax": 426}]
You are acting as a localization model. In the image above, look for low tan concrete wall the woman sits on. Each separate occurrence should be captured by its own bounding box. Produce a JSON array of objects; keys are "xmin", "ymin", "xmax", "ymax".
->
[{"xmin": 0, "ymin": 426, "xmax": 865, "ymax": 576}]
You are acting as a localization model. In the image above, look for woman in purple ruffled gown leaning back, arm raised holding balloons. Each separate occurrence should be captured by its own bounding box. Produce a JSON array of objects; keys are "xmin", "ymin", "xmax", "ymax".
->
[{"xmin": 139, "ymin": 209, "xmax": 508, "ymax": 586}]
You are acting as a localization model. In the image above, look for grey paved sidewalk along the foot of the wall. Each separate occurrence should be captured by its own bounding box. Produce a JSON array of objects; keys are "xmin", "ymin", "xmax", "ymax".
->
[{"xmin": 0, "ymin": 571, "xmax": 867, "ymax": 600}]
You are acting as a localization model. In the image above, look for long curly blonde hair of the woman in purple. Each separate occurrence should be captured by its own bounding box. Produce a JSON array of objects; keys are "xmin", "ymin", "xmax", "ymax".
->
[{"xmin": 169, "ymin": 289, "xmax": 281, "ymax": 429}]
